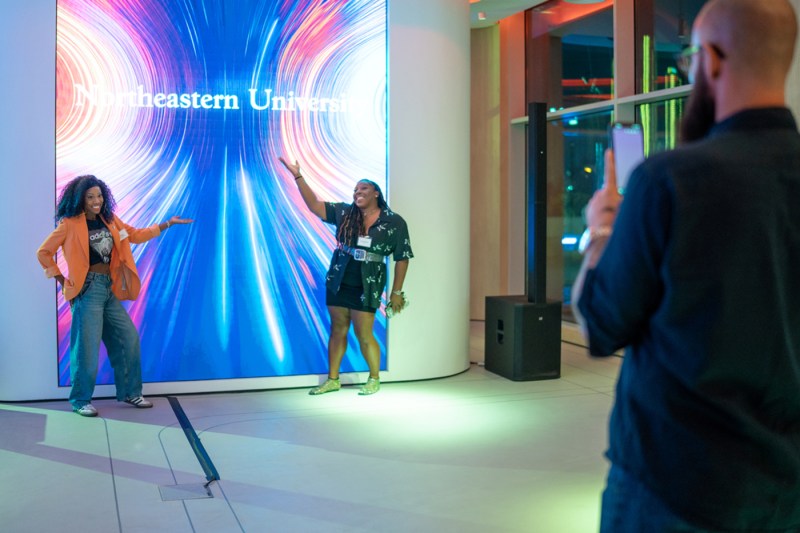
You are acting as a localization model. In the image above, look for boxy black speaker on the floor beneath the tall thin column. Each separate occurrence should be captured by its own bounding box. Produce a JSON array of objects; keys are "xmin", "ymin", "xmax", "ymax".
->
[{"xmin": 484, "ymin": 296, "xmax": 561, "ymax": 381}]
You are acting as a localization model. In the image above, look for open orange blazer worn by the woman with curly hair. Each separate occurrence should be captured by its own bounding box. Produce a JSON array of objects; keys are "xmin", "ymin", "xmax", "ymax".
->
[{"xmin": 36, "ymin": 213, "xmax": 161, "ymax": 301}]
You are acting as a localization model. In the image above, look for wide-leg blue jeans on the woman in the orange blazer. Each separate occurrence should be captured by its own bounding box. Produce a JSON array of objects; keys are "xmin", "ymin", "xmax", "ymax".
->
[{"xmin": 69, "ymin": 272, "xmax": 142, "ymax": 409}]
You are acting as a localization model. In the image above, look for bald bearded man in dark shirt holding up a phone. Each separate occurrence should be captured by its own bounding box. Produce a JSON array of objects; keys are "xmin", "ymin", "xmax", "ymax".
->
[{"xmin": 573, "ymin": 0, "xmax": 800, "ymax": 533}]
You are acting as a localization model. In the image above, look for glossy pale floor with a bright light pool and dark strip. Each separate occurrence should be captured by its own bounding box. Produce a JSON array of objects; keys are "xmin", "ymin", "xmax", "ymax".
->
[{"xmin": 0, "ymin": 322, "xmax": 621, "ymax": 533}]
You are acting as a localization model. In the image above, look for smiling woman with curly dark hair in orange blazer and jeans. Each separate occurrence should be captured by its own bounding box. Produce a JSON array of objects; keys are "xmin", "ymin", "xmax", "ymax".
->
[{"xmin": 36, "ymin": 175, "xmax": 192, "ymax": 416}]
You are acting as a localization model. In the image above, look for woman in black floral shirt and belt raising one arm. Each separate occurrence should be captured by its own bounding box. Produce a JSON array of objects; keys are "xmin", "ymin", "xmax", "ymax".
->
[{"xmin": 280, "ymin": 157, "xmax": 414, "ymax": 395}]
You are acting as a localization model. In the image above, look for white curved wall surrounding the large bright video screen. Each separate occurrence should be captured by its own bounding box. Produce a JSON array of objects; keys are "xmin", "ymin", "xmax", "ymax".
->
[{"xmin": 0, "ymin": 0, "xmax": 470, "ymax": 401}]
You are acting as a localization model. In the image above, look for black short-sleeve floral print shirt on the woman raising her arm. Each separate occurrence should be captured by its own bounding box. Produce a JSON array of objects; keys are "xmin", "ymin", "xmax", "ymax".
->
[{"xmin": 324, "ymin": 202, "xmax": 414, "ymax": 309}]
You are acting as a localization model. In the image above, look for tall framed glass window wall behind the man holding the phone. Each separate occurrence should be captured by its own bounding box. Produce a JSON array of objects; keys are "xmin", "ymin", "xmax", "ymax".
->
[{"xmin": 526, "ymin": 0, "xmax": 705, "ymax": 320}]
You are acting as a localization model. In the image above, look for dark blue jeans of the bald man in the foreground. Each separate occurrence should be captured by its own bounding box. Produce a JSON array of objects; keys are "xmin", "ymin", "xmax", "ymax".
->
[{"xmin": 600, "ymin": 465, "xmax": 711, "ymax": 533}]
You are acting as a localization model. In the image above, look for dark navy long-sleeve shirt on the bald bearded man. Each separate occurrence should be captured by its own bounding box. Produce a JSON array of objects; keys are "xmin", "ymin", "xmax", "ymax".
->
[{"xmin": 578, "ymin": 108, "xmax": 800, "ymax": 531}]
